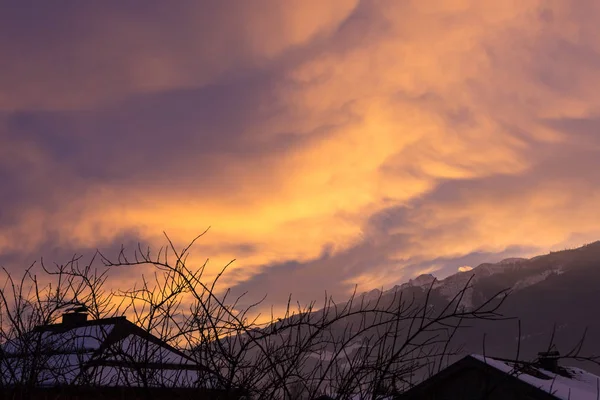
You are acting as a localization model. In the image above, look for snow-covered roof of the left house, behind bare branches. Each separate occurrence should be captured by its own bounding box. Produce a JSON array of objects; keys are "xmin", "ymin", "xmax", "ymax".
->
[{"xmin": 0, "ymin": 317, "xmax": 216, "ymax": 387}]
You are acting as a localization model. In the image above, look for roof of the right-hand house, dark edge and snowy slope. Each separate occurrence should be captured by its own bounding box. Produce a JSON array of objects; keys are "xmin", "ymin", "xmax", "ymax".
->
[{"xmin": 401, "ymin": 354, "xmax": 600, "ymax": 400}]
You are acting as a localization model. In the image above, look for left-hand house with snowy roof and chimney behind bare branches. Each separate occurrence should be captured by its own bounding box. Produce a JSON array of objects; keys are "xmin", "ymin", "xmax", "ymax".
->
[{"xmin": 0, "ymin": 309, "xmax": 244, "ymax": 400}]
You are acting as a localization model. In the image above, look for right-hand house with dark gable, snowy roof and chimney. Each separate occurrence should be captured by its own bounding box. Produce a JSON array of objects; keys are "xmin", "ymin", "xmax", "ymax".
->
[{"xmin": 399, "ymin": 352, "xmax": 600, "ymax": 400}]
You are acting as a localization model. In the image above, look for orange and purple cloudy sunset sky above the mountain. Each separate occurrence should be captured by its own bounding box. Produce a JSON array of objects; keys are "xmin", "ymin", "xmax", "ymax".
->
[{"xmin": 0, "ymin": 0, "xmax": 600, "ymax": 306}]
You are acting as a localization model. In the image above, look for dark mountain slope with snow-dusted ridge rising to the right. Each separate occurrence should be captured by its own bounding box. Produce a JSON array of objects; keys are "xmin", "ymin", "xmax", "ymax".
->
[{"xmin": 224, "ymin": 242, "xmax": 600, "ymax": 396}]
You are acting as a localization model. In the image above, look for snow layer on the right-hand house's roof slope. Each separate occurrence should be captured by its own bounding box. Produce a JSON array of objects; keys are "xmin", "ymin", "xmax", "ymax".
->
[{"xmin": 471, "ymin": 354, "xmax": 600, "ymax": 400}]
